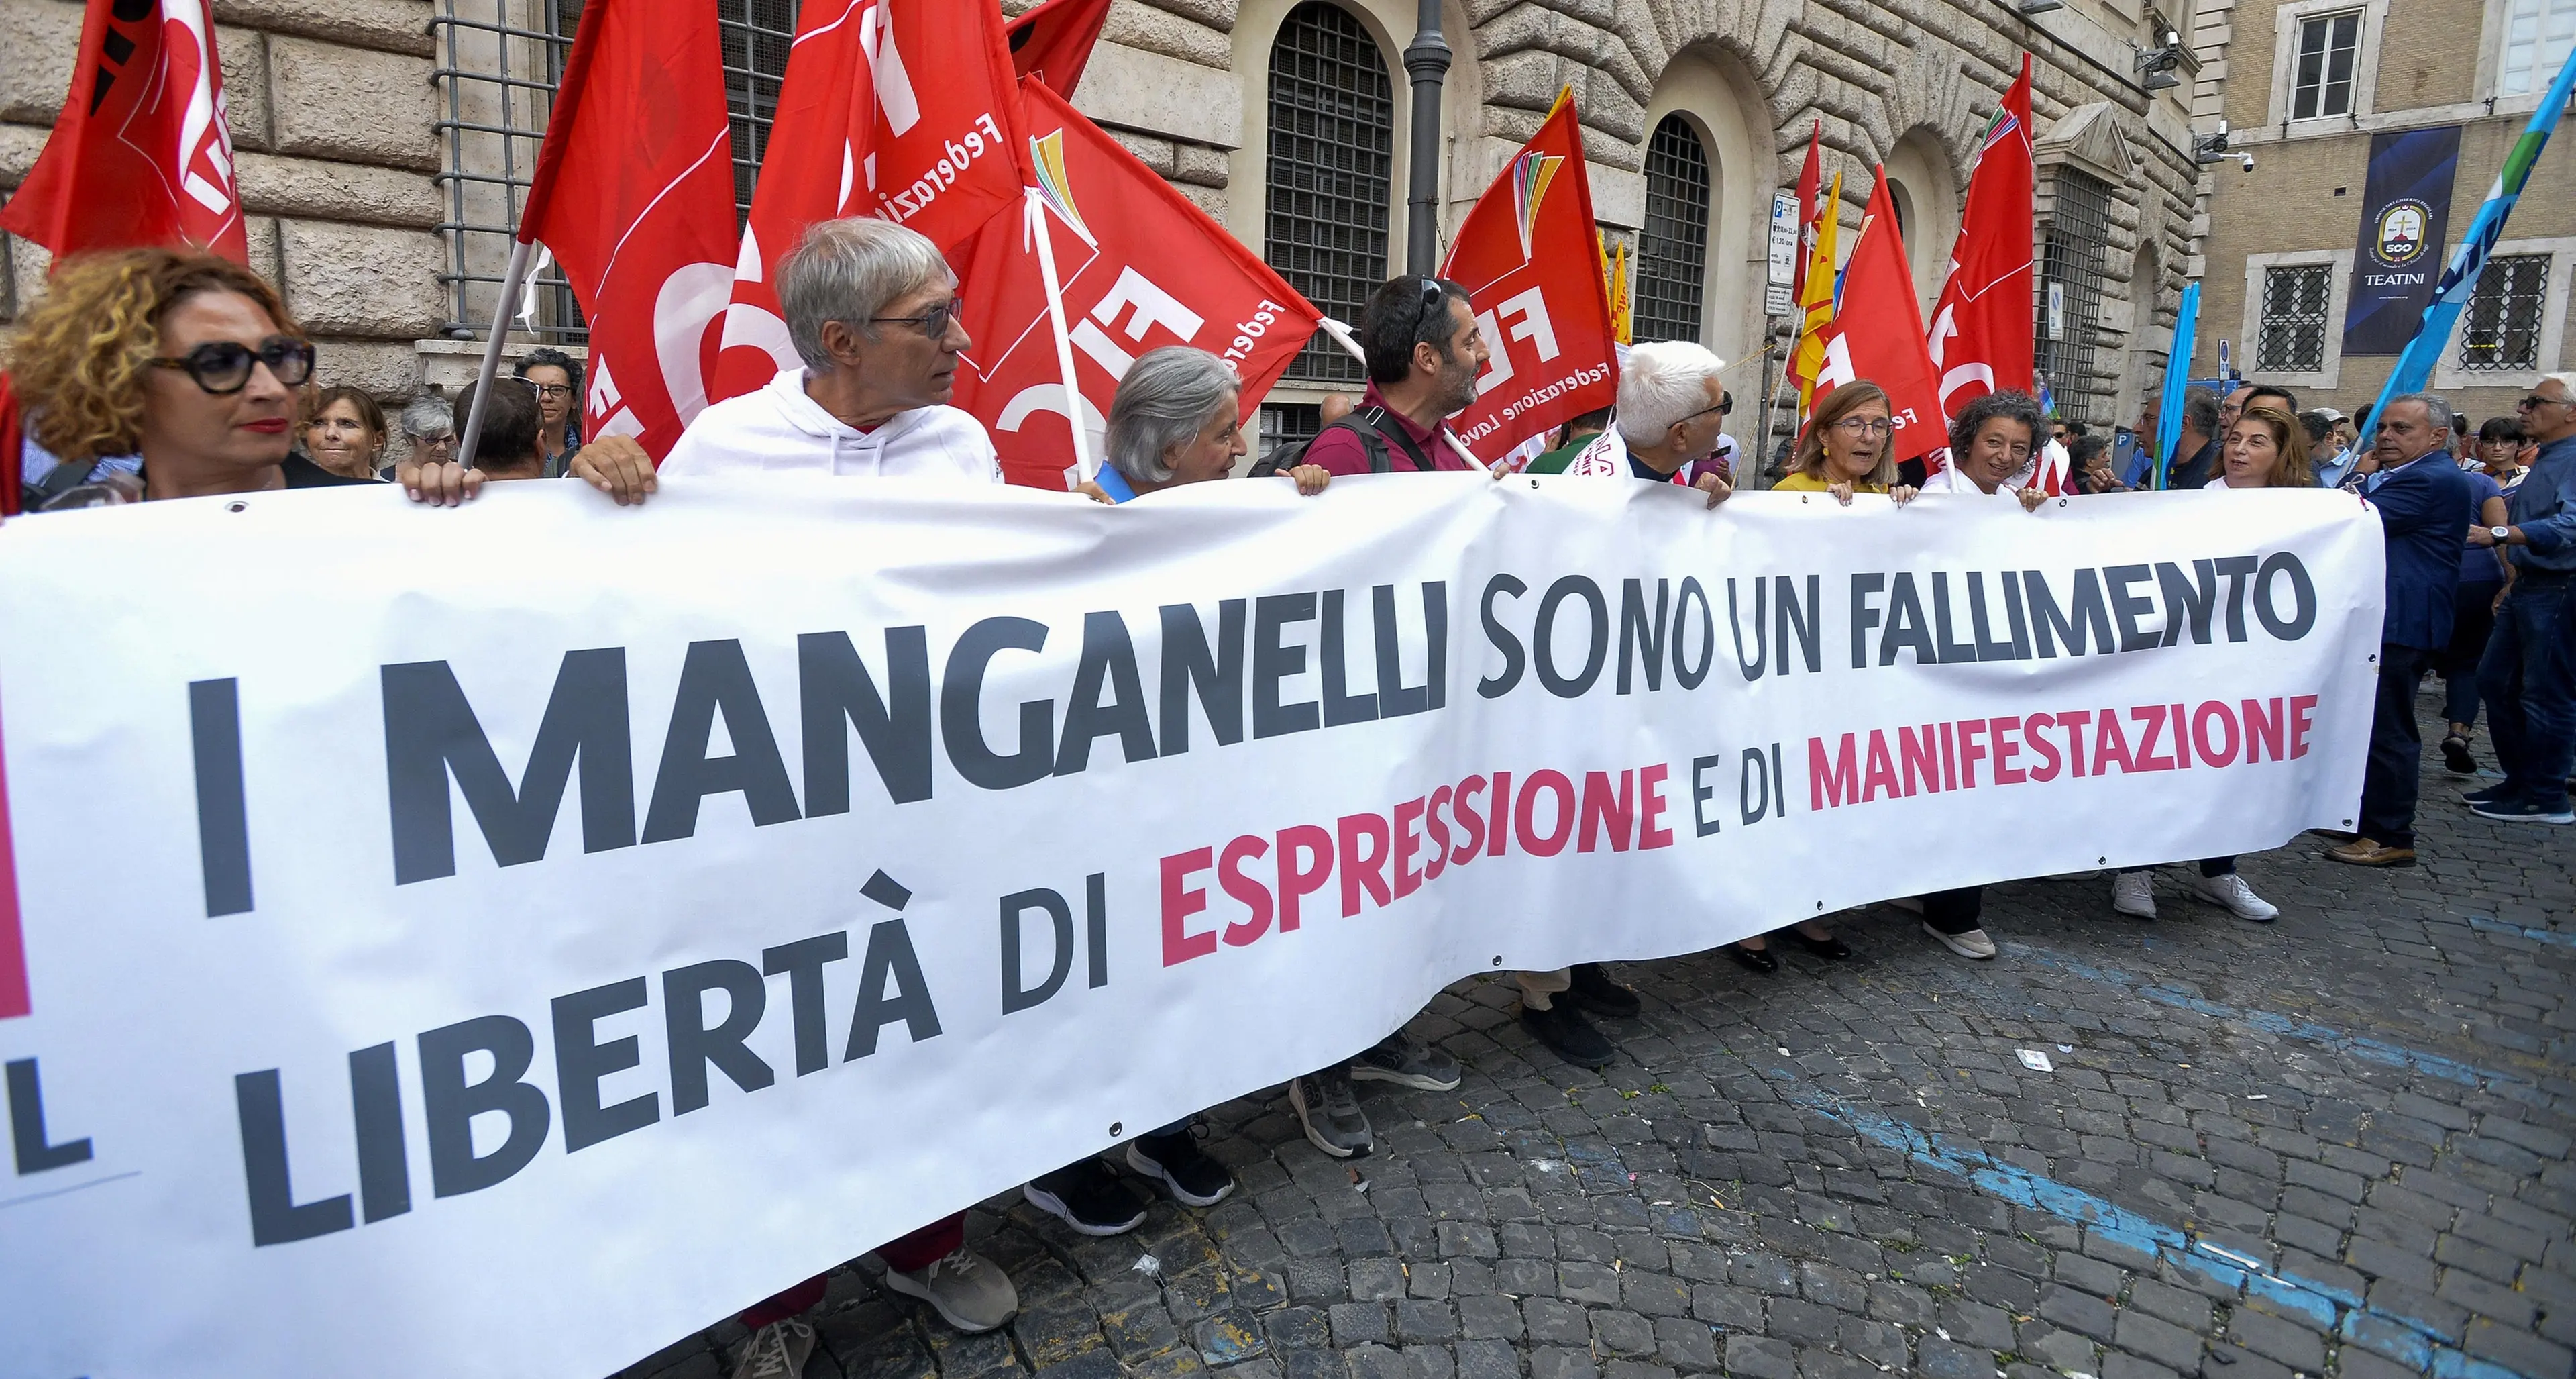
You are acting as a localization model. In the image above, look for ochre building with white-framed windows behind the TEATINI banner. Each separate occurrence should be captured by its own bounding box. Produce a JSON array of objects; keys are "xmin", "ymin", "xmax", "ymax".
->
[{"xmin": 2192, "ymin": 0, "xmax": 2576, "ymax": 420}]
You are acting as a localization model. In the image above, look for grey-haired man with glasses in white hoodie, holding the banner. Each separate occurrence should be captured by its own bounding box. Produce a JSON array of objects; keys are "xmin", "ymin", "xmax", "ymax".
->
[{"xmin": 572, "ymin": 217, "xmax": 1002, "ymax": 505}]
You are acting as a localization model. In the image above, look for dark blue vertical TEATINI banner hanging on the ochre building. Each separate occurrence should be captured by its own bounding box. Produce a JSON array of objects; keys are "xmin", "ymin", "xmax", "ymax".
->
[{"xmin": 2344, "ymin": 123, "xmax": 2460, "ymax": 356}]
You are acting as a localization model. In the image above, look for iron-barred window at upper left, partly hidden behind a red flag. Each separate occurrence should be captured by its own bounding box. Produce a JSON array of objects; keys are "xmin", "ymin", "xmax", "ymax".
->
[{"xmin": 430, "ymin": 0, "xmax": 798, "ymax": 346}]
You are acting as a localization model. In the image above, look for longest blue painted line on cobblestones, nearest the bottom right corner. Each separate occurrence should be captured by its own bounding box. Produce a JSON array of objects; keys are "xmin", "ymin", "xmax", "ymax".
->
[{"xmin": 1762, "ymin": 1067, "xmax": 2517, "ymax": 1379}]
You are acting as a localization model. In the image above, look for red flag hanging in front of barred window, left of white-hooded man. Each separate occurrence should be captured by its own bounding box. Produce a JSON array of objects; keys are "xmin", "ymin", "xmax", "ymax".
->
[{"xmin": 518, "ymin": 0, "xmax": 734, "ymax": 462}]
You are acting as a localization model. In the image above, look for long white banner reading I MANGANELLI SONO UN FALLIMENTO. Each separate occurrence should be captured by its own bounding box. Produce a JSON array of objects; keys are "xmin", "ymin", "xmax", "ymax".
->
[{"xmin": 0, "ymin": 474, "xmax": 2383, "ymax": 1379}]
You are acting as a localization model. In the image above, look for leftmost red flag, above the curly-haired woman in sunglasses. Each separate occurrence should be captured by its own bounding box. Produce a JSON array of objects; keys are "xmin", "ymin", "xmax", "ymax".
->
[{"xmin": 0, "ymin": 0, "xmax": 250, "ymax": 263}]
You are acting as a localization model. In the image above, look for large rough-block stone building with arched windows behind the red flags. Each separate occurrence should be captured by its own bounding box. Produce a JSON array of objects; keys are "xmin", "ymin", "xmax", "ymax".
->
[{"xmin": 0, "ymin": 0, "xmax": 2215, "ymax": 454}]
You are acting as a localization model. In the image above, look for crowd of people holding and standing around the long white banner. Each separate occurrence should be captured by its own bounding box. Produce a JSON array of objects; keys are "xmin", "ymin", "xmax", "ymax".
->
[{"xmin": 8, "ymin": 232, "xmax": 2576, "ymax": 1376}]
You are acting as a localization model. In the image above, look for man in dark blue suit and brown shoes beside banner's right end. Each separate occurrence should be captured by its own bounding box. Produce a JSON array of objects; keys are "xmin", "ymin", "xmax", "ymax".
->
[{"xmin": 2326, "ymin": 392, "xmax": 2478, "ymax": 866}]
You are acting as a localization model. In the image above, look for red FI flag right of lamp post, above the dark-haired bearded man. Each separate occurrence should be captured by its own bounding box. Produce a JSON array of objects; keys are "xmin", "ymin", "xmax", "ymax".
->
[{"xmin": 1440, "ymin": 90, "xmax": 1618, "ymax": 464}]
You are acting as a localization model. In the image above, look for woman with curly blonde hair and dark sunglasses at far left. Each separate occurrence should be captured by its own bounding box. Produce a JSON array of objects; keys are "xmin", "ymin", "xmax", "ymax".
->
[{"xmin": 8, "ymin": 250, "xmax": 363, "ymax": 508}]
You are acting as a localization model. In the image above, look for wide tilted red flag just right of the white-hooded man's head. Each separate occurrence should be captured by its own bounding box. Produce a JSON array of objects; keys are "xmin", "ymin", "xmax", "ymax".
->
[{"xmin": 956, "ymin": 77, "xmax": 1316, "ymax": 490}]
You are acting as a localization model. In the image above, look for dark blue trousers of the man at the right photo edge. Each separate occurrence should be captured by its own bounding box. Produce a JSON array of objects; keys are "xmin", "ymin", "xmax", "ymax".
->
[{"xmin": 2478, "ymin": 572, "xmax": 2576, "ymax": 807}]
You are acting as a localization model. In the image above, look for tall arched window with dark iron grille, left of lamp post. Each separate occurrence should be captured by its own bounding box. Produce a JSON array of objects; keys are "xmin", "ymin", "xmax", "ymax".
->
[{"xmin": 1263, "ymin": 0, "xmax": 1396, "ymax": 384}]
